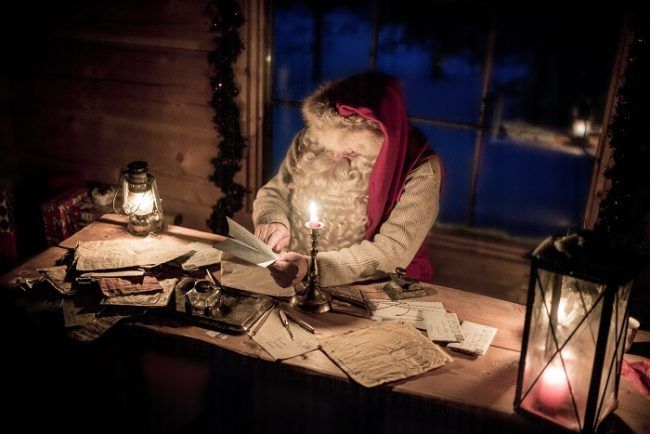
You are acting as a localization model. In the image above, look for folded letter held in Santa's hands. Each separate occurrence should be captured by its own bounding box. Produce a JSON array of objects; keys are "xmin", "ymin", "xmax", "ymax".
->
[{"xmin": 214, "ymin": 218, "xmax": 278, "ymax": 268}]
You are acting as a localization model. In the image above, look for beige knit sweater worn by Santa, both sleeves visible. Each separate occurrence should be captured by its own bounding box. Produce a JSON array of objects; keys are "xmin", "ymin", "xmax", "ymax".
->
[{"xmin": 253, "ymin": 132, "xmax": 441, "ymax": 286}]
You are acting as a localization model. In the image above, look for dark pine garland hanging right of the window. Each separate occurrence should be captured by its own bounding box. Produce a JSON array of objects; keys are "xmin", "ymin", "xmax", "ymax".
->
[{"xmin": 595, "ymin": 7, "xmax": 650, "ymax": 248}]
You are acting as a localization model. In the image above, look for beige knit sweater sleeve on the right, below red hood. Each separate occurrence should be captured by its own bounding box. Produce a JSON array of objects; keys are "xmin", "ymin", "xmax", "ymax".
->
[{"xmin": 317, "ymin": 158, "xmax": 441, "ymax": 286}]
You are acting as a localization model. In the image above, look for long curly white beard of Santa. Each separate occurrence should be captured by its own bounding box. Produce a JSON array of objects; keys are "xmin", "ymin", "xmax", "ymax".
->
[{"xmin": 289, "ymin": 140, "xmax": 374, "ymax": 254}]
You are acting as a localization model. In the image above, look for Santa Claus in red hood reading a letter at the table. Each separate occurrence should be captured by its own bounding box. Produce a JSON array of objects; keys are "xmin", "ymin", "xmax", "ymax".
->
[{"xmin": 253, "ymin": 71, "xmax": 442, "ymax": 286}]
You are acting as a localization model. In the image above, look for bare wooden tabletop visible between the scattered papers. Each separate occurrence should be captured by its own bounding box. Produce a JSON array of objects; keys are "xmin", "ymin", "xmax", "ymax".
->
[{"xmin": 0, "ymin": 216, "xmax": 650, "ymax": 433}]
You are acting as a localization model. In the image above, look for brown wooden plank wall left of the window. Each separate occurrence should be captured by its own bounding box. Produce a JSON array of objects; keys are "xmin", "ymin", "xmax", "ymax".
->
[{"xmin": 0, "ymin": 0, "xmax": 252, "ymax": 234}]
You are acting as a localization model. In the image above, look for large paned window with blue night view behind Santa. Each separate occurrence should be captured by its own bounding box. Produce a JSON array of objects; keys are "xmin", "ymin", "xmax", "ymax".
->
[{"xmin": 267, "ymin": 0, "xmax": 622, "ymax": 238}]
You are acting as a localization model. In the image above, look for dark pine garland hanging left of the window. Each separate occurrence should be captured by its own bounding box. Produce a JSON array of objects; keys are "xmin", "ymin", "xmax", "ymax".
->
[{"xmin": 204, "ymin": 0, "xmax": 246, "ymax": 234}]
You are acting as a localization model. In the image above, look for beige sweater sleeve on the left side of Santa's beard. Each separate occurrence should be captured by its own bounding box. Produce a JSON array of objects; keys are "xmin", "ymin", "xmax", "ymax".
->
[{"xmin": 253, "ymin": 130, "xmax": 304, "ymax": 230}]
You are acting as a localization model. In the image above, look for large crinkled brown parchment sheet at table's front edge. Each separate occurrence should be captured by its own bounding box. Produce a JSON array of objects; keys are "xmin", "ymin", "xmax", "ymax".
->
[{"xmin": 320, "ymin": 321, "xmax": 453, "ymax": 387}]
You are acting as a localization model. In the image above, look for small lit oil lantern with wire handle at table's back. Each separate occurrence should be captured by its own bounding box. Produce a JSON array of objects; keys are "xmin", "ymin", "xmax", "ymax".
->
[{"xmin": 113, "ymin": 161, "xmax": 163, "ymax": 235}]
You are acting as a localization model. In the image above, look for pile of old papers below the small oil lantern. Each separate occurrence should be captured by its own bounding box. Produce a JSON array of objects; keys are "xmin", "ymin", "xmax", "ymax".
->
[{"xmin": 23, "ymin": 235, "xmax": 221, "ymax": 341}]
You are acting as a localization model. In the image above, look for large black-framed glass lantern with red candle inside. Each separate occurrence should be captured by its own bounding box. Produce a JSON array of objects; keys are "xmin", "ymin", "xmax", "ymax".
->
[{"xmin": 515, "ymin": 231, "xmax": 646, "ymax": 432}]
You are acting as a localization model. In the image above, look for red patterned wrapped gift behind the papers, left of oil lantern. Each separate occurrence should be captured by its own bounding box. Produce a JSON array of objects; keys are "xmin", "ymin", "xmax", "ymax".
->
[{"xmin": 41, "ymin": 188, "xmax": 92, "ymax": 245}]
